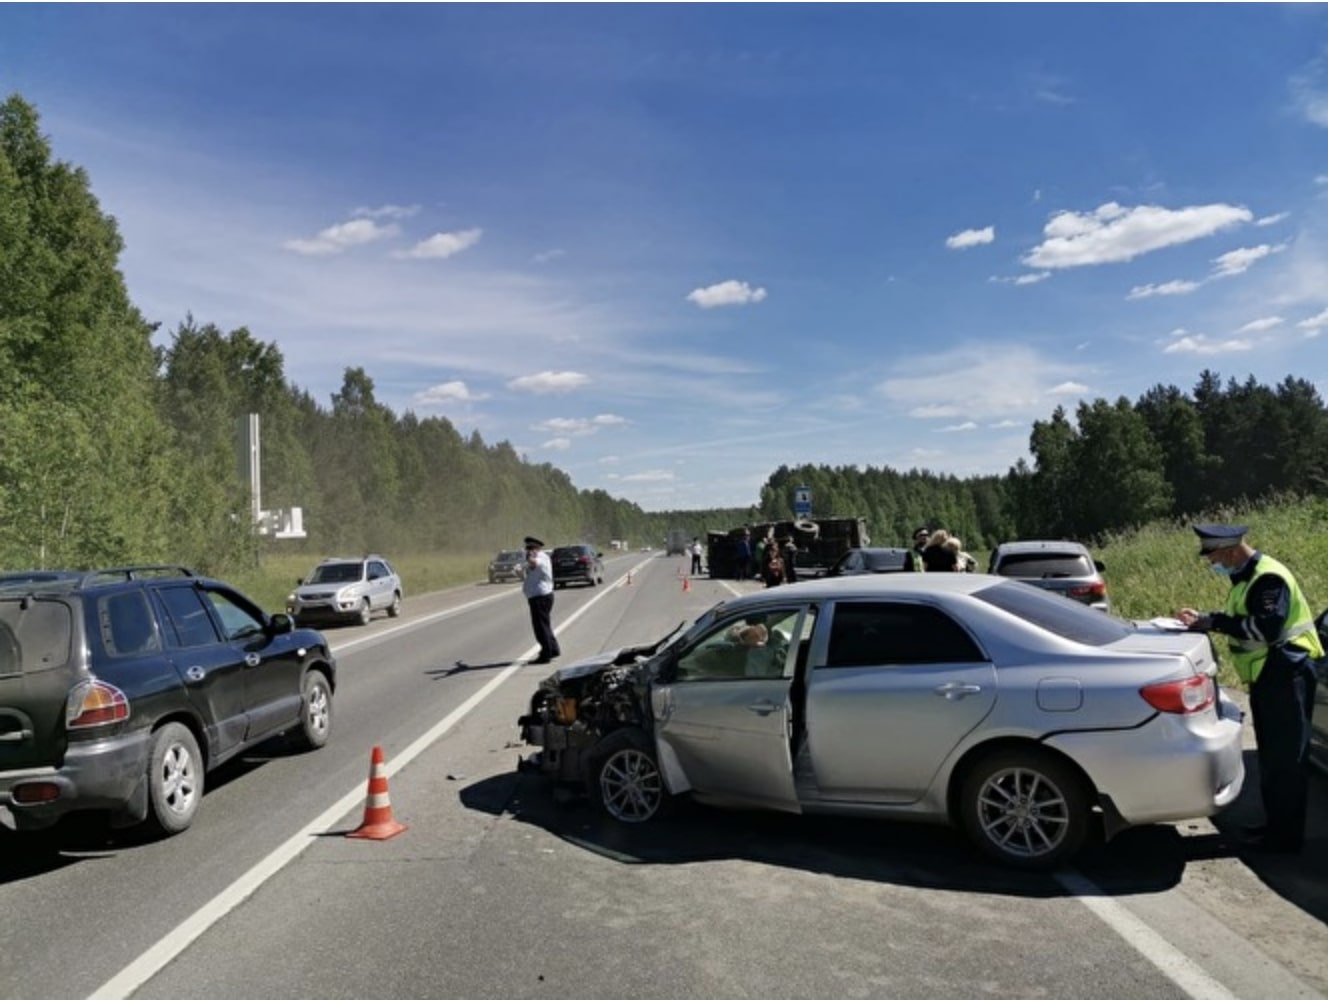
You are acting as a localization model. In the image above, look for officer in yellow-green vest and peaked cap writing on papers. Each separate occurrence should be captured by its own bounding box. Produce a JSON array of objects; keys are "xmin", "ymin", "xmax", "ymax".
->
[{"xmin": 1177, "ymin": 526, "xmax": 1324, "ymax": 852}]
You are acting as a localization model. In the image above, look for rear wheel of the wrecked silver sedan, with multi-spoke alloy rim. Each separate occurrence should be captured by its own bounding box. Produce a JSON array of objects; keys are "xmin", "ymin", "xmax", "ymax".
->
[{"xmin": 959, "ymin": 749, "xmax": 1090, "ymax": 869}]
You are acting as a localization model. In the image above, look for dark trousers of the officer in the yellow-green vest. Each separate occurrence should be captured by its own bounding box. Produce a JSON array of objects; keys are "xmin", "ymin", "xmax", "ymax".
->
[{"xmin": 1250, "ymin": 648, "xmax": 1316, "ymax": 848}]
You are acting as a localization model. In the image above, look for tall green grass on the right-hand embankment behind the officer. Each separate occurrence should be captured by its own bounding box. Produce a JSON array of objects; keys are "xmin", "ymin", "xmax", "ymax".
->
[{"xmin": 1093, "ymin": 499, "xmax": 1328, "ymax": 686}]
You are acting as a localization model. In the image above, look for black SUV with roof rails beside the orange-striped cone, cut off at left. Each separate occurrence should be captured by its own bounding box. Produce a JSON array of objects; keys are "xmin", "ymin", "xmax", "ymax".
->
[{"xmin": 0, "ymin": 567, "xmax": 336, "ymax": 835}]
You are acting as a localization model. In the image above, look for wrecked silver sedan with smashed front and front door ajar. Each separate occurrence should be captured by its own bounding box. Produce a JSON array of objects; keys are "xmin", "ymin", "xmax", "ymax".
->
[{"xmin": 518, "ymin": 573, "xmax": 1244, "ymax": 868}]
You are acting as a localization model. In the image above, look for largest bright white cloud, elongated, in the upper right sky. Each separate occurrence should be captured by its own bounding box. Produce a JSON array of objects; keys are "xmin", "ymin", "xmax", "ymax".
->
[{"xmin": 1024, "ymin": 202, "xmax": 1254, "ymax": 268}]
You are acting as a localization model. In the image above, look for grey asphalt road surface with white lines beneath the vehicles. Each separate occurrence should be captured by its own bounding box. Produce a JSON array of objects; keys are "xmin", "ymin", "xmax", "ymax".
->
[{"xmin": 0, "ymin": 553, "xmax": 1328, "ymax": 999}]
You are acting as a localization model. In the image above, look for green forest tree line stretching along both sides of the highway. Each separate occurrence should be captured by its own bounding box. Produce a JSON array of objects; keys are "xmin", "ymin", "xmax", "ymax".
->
[{"xmin": 0, "ymin": 96, "xmax": 1328, "ymax": 575}]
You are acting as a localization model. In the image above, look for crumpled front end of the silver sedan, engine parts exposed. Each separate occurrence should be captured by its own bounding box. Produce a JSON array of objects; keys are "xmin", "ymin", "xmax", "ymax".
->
[{"xmin": 517, "ymin": 650, "xmax": 648, "ymax": 783}]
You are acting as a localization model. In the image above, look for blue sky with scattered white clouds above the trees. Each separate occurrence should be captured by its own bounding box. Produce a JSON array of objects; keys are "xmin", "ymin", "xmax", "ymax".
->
[{"xmin": 0, "ymin": 4, "xmax": 1328, "ymax": 511}]
